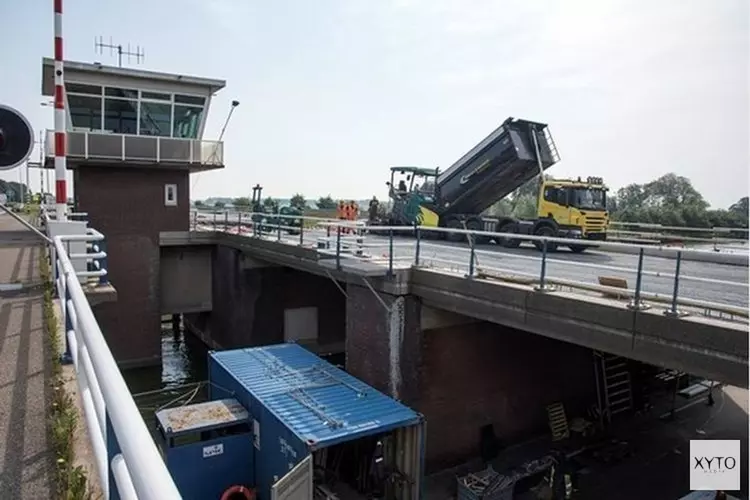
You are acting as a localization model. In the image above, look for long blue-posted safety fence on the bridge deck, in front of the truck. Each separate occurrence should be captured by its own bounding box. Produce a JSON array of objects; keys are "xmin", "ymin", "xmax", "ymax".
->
[{"xmin": 192, "ymin": 212, "xmax": 748, "ymax": 321}]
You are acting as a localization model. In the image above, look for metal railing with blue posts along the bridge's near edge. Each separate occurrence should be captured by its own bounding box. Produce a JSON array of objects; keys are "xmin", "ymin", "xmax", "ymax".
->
[{"xmin": 192, "ymin": 211, "xmax": 748, "ymax": 318}]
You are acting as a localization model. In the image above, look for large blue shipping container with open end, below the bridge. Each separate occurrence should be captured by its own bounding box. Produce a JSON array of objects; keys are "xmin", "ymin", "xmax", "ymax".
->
[{"xmin": 209, "ymin": 344, "xmax": 425, "ymax": 500}]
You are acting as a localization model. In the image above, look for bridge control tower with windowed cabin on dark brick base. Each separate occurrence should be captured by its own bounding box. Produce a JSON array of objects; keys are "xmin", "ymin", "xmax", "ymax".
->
[{"xmin": 42, "ymin": 58, "xmax": 226, "ymax": 367}]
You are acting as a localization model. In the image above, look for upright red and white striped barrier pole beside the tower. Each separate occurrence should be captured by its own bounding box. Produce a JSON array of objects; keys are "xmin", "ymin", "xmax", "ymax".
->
[{"xmin": 53, "ymin": 0, "xmax": 68, "ymax": 221}]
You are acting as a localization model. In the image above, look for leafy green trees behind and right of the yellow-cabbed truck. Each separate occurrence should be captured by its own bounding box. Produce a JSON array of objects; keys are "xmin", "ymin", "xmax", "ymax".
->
[{"xmin": 487, "ymin": 174, "xmax": 748, "ymax": 228}]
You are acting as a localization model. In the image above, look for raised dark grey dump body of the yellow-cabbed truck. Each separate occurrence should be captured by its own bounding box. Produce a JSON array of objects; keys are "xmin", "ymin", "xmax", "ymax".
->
[{"xmin": 437, "ymin": 118, "xmax": 559, "ymax": 216}]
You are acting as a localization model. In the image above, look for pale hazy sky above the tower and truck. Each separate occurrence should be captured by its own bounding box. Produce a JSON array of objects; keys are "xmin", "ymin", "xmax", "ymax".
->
[{"xmin": 0, "ymin": 0, "xmax": 750, "ymax": 208}]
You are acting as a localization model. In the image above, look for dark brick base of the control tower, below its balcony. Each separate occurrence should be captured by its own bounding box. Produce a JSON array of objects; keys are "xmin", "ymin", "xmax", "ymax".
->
[{"xmin": 75, "ymin": 167, "xmax": 190, "ymax": 366}]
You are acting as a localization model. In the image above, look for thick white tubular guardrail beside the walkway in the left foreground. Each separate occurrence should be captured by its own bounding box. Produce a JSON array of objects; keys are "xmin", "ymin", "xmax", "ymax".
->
[{"xmin": 43, "ymin": 212, "xmax": 181, "ymax": 500}]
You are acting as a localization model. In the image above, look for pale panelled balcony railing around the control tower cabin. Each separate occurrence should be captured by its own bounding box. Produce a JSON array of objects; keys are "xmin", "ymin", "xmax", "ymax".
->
[{"xmin": 45, "ymin": 130, "xmax": 224, "ymax": 166}]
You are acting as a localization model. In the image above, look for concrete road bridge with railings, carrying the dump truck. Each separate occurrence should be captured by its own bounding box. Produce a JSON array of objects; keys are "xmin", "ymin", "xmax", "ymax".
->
[{"xmin": 166, "ymin": 214, "xmax": 748, "ymax": 386}]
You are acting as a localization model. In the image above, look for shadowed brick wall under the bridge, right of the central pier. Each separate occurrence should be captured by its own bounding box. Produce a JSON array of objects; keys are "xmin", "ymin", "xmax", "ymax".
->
[{"xmin": 415, "ymin": 323, "xmax": 596, "ymax": 470}]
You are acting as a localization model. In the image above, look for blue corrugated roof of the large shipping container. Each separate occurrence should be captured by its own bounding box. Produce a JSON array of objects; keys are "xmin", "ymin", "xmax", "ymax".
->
[{"xmin": 210, "ymin": 344, "xmax": 422, "ymax": 448}]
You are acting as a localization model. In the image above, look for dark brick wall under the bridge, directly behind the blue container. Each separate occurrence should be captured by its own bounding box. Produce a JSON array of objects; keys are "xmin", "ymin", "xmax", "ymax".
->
[{"xmin": 186, "ymin": 245, "xmax": 345, "ymax": 348}]
